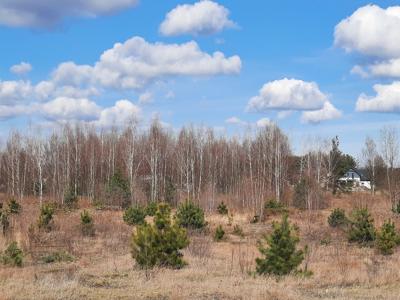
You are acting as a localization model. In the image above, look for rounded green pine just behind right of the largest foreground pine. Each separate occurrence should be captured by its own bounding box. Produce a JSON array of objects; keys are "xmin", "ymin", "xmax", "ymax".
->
[{"xmin": 176, "ymin": 201, "xmax": 206, "ymax": 229}]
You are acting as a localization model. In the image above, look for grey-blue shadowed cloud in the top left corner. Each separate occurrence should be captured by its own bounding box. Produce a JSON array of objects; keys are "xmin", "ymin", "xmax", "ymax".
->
[{"xmin": 0, "ymin": 0, "xmax": 138, "ymax": 28}]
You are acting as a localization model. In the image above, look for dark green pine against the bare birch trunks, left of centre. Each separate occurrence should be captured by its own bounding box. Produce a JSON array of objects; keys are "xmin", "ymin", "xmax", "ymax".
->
[{"xmin": 106, "ymin": 171, "xmax": 131, "ymax": 208}]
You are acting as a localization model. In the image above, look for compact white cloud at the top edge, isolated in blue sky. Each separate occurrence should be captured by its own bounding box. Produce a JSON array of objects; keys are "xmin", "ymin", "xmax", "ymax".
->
[{"xmin": 160, "ymin": 0, "xmax": 235, "ymax": 36}]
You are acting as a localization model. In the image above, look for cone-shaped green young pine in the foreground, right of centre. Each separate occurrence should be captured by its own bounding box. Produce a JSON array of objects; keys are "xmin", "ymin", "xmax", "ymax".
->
[{"xmin": 256, "ymin": 215, "xmax": 304, "ymax": 275}]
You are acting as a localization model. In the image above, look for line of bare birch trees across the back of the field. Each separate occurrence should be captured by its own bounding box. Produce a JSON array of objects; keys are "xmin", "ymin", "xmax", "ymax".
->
[{"xmin": 0, "ymin": 121, "xmax": 399, "ymax": 211}]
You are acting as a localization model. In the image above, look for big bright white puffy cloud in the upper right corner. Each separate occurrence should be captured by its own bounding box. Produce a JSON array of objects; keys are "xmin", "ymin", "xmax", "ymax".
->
[{"xmin": 335, "ymin": 5, "xmax": 400, "ymax": 78}]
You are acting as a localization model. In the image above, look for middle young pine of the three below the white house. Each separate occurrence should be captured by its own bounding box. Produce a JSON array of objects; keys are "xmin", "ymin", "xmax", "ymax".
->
[{"xmin": 348, "ymin": 208, "xmax": 376, "ymax": 246}]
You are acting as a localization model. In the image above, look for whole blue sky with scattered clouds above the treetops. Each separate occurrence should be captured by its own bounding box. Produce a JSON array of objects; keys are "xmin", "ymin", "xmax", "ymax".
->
[{"xmin": 0, "ymin": 0, "xmax": 400, "ymax": 156}]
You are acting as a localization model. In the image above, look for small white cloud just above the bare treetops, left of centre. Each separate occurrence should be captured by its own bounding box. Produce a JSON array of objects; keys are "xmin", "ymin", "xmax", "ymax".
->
[{"xmin": 95, "ymin": 100, "xmax": 141, "ymax": 128}]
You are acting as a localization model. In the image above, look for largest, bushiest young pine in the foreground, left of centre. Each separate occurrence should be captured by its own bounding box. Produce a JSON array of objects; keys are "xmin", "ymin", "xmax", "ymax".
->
[{"xmin": 131, "ymin": 203, "xmax": 189, "ymax": 269}]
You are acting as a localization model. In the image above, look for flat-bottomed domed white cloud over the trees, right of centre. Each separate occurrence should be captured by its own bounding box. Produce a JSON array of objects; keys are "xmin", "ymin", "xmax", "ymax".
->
[{"xmin": 247, "ymin": 78, "xmax": 328, "ymax": 112}]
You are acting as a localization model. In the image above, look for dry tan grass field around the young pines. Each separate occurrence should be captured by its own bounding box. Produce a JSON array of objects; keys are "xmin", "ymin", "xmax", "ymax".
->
[{"xmin": 0, "ymin": 194, "xmax": 400, "ymax": 300}]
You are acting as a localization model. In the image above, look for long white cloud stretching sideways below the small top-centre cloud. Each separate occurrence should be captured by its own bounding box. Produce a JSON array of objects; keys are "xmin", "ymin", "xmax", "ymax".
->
[{"xmin": 93, "ymin": 37, "xmax": 241, "ymax": 89}]
